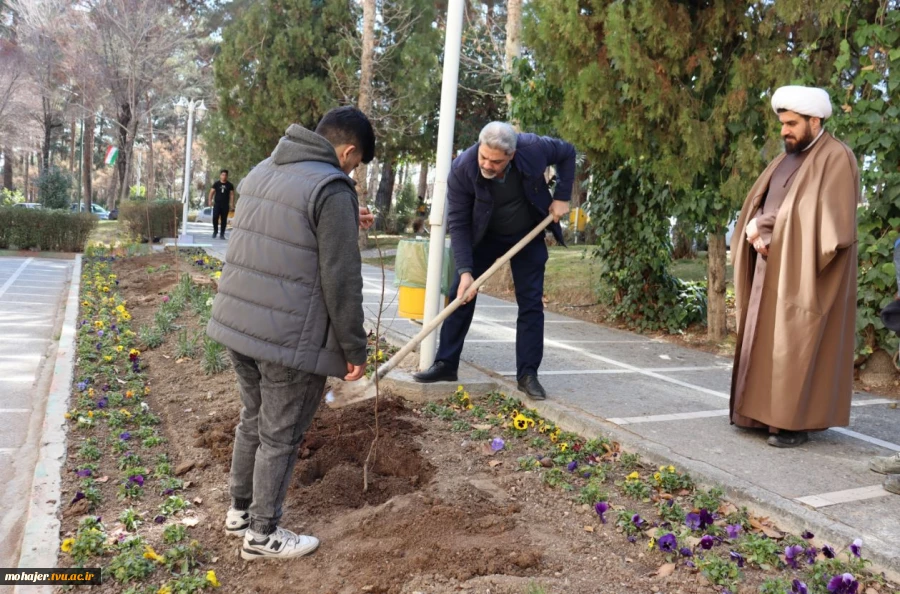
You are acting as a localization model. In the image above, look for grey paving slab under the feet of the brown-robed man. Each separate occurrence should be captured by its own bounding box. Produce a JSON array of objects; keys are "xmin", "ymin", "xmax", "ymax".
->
[{"xmin": 624, "ymin": 417, "xmax": 890, "ymax": 499}]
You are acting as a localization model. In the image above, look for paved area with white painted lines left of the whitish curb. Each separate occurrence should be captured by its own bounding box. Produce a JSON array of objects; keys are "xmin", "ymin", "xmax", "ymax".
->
[{"xmin": 0, "ymin": 258, "xmax": 73, "ymax": 567}]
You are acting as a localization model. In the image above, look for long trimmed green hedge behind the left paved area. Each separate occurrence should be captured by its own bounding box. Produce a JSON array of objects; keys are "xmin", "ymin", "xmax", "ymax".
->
[{"xmin": 0, "ymin": 206, "xmax": 97, "ymax": 252}]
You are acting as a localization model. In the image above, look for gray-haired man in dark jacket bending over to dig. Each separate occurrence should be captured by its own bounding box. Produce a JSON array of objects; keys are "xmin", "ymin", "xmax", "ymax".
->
[{"xmin": 413, "ymin": 122, "xmax": 575, "ymax": 400}]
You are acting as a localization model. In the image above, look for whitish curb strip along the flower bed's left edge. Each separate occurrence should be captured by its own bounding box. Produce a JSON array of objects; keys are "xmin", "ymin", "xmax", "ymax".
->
[{"xmin": 13, "ymin": 254, "xmax": 82, "ymax": 594}]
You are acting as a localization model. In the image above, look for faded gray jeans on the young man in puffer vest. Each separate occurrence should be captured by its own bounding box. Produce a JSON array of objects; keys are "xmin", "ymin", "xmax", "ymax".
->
[{"xmin": 228, "ymin": 349, "xmax": 326, "ymax": 534}]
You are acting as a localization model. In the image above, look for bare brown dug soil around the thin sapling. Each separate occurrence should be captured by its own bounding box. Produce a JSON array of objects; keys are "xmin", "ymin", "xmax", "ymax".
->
[{"xmin": 62, "ymin": 255, "xmax": 892, "ymax": 594}]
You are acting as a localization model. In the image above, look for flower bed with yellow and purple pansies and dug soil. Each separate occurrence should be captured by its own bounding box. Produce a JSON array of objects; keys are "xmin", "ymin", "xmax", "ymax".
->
[{"xmin": 61, "ymin": 254, "xmax": 896, "ymax": 594}]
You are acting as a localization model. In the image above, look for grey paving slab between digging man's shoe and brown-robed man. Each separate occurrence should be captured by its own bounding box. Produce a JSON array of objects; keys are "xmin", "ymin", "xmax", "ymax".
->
[{"xmin": 539, "ymin": 374, "xmax": 728, "ymax": 418}]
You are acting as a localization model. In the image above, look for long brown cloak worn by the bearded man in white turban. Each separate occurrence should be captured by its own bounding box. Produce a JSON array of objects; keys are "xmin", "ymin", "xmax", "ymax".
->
[{"xmin": 731, "ymin": 132, "xmax": 859, "ymax": 431}]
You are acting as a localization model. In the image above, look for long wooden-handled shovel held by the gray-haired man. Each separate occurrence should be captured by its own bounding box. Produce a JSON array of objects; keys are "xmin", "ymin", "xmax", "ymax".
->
[{"xmin": 325, "ymin": 215, "xmax": 553, "ymax": 408}]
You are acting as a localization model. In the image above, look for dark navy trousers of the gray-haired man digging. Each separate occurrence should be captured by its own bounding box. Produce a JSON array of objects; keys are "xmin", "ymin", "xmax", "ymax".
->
[{"xmin": 435, "ymin": 233, "xmax": 547, "ymax": 379}]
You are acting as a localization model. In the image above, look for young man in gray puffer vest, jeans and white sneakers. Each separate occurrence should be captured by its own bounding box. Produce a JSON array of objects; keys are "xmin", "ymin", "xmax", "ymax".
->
[{"xmin": 206, "ymin": 107, "xmax": 375, "ymax": 560}]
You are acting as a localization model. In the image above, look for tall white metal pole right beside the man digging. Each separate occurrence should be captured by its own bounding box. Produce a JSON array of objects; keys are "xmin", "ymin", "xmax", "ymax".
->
[{"xmin": 419, "ymin": 0, "xmax": 463, "ymax": 369}]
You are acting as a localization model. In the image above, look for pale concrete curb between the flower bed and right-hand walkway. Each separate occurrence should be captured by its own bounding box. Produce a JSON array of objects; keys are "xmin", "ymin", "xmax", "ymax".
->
[{"xmin": 370, "ymin": 316, "xmax": 900, "ymax": 581}]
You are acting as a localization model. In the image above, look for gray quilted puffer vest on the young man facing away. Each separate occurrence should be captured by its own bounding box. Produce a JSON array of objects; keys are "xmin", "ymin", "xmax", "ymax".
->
[{"xmin": 207, "ymin": 135, "xmax": 355, "ymax": 377}]
